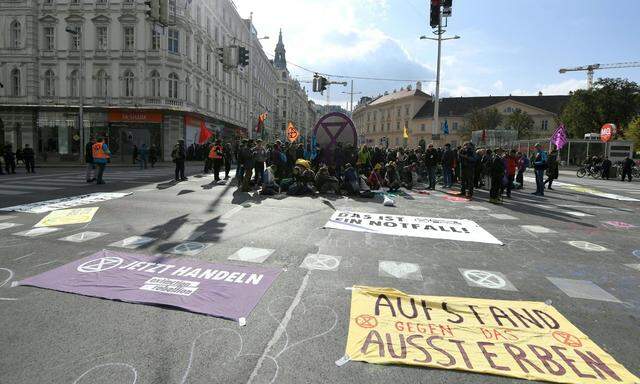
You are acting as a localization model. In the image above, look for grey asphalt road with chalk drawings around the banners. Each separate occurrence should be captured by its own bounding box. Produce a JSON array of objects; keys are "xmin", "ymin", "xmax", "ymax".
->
[{"xmin": 0, "ymin": 167, "xmax": 640, "ymax": 384}]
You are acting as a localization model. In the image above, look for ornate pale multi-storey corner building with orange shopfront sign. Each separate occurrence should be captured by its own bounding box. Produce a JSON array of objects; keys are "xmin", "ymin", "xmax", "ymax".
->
[{"xmin": 0, "ymin": 0, "xmax": 307, "ymax": 161}]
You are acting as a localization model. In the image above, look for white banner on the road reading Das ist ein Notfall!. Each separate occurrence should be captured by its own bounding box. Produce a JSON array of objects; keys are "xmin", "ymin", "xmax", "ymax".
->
[{"xmin": 325, "ymin": 211, "xmax": 503, "ymax": 245}]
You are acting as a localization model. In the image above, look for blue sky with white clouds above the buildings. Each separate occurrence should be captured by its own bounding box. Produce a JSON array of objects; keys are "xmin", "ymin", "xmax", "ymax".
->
[{"xmin": 235, "ymin": 0, "xmax": 640, "ymax": 108}]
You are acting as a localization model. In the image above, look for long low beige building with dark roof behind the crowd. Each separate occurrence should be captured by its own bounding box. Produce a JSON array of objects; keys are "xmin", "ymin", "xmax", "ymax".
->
[{"xmin": 353, "ymin": 84, "xmax": 570, "ymax": 147}]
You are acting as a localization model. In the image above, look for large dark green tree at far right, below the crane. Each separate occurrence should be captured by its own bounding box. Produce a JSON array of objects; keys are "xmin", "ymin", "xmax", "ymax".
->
[{"xmin": 560, "ymin": 78, "xmax": 640, "ymax": 138}]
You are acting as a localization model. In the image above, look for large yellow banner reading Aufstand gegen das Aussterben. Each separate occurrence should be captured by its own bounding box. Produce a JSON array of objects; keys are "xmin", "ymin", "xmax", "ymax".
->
[{"xmin": 346, "ymin": 286, "xmax": 640, "ymax": 384}]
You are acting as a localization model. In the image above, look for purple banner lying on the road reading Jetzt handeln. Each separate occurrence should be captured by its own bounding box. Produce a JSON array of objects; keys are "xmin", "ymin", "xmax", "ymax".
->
[{"xmin": 20, "ymin": 250, "xmax": 280, "ymax": 320}]
